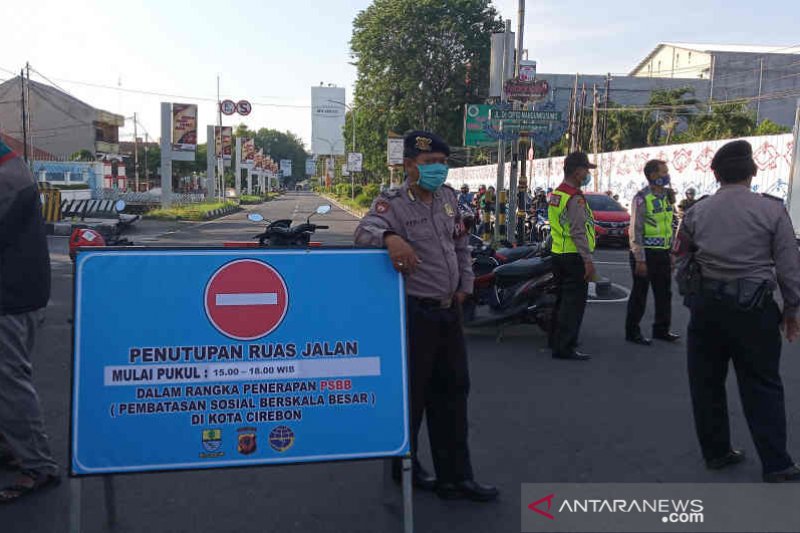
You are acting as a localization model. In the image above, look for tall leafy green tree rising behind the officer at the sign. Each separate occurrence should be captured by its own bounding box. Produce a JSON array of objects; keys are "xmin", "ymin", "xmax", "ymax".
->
[{"xmin": 345, "ymin": 0, "xmax": 503, "ymax": 176}]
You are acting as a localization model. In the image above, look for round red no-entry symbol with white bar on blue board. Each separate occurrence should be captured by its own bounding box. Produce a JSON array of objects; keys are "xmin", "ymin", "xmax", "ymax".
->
[{"xmin": 205, "ymin": 259, "xmax": 289, "ymax": 341}]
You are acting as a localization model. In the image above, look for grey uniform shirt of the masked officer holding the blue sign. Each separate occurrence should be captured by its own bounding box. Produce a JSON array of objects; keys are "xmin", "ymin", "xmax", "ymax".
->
[{"xmin": 355, "ymin": 182, "xmax": 474, "ymax": 300}]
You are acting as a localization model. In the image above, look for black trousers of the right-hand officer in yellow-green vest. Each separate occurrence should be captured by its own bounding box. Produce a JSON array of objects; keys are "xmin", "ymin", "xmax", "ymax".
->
[{"xmin": 625, "ymin": 248, "xmax": 672, "ymax": 337}]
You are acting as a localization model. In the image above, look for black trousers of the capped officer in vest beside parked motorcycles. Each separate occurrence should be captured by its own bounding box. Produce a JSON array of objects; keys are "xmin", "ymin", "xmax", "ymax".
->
[{"xmin": 550, "ymin": 253, "xmax": 589, "ymax": 356}]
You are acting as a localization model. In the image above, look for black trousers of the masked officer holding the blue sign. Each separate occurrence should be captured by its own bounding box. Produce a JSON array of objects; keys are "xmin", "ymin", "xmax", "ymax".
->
[{"xmin": 407, "ymin": 297, "xmax": 473, "ymax": 483}]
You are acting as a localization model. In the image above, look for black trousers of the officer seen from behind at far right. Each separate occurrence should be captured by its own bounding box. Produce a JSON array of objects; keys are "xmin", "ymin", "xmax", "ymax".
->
[{"xmin": 687, "ymin": 293, "xmax": 792, "ymax": 473}]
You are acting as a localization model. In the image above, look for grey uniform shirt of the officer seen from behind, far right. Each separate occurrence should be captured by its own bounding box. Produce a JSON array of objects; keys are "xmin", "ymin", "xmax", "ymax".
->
[{"xmin": 679, "ymin": 185, "xmax": 800, "ymax": 316}]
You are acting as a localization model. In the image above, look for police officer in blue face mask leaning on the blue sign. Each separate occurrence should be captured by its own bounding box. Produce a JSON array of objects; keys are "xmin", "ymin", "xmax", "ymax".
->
[{"xmin": 355, "ymin": 131, "xmax": 498, "ymax": 501}]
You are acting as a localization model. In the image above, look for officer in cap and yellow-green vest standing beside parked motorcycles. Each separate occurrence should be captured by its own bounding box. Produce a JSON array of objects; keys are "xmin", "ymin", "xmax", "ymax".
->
[{"xmin": 547, "ymin": 152, "xmax": 597, "ymax": 360}]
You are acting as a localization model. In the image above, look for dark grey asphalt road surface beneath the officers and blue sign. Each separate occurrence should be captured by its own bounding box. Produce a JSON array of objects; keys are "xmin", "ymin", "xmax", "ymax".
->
[{"xmin": 6, "ymin": 194, "xmax": 800, "ymax": 533}]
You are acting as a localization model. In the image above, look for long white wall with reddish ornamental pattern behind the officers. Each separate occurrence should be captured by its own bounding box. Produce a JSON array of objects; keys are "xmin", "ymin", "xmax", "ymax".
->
[{"xmin": 447, "ymin": 133, "xmax": 793, "ymax": 205}]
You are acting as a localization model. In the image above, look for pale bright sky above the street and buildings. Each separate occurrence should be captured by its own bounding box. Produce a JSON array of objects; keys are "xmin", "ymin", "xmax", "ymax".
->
[{"xmin": 0, "ymin": 0, "xmax": 800, "ymax": 151}]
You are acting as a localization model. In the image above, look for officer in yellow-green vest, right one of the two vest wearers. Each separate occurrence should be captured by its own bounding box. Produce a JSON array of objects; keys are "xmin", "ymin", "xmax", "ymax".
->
[{"xmin": 625, "ymin": 159, "xmax": 680, "ymax": 346}]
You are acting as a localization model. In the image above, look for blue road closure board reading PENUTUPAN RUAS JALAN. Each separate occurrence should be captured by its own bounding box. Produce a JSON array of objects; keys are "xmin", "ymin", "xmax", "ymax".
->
[{"xmin": 70, "ymin": 249, "xmax": 409, "ymax": 476}]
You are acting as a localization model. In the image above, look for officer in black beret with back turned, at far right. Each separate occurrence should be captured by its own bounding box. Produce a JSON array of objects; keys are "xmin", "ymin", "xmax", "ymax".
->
[{"xmin": 675, "ymin": 141, "xmax": 800, "ymax": 483}]
